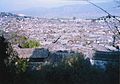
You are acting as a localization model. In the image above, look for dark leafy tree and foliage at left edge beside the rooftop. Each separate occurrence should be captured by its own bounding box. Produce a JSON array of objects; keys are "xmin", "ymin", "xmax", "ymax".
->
[{"xmin": 0, "ymin": 36, "xmax": 28, "ymax": 84}]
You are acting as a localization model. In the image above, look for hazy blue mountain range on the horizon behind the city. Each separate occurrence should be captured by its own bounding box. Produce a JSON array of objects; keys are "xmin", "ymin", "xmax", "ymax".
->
[{"xmin": 13, "ymin": 2, "xmax": 120, "ymax": 18}]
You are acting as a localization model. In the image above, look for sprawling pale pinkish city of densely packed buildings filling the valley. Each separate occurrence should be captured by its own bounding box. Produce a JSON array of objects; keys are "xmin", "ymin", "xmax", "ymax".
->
[{"xmin": 0, "ymin": 12, "xmax": 120, "ymax": 55}]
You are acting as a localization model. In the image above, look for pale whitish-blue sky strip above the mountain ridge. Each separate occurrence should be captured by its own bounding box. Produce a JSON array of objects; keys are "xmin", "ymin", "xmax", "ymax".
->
[{"xmin": 0, "ymin": 0, "xmax": 113, "ymax": 11}]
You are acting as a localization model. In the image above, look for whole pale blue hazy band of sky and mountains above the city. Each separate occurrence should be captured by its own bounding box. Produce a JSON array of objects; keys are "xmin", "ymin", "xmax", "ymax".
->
[{"xmin": 0, "ymin": 0, "xmax": 120, "ymax": 18}]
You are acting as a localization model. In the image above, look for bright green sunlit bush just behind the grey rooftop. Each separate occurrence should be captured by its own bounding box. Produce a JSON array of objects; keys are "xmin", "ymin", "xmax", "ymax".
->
[{"xmin": 21, "ymin": 40, "xmax": 40, "ymax": 48}]
